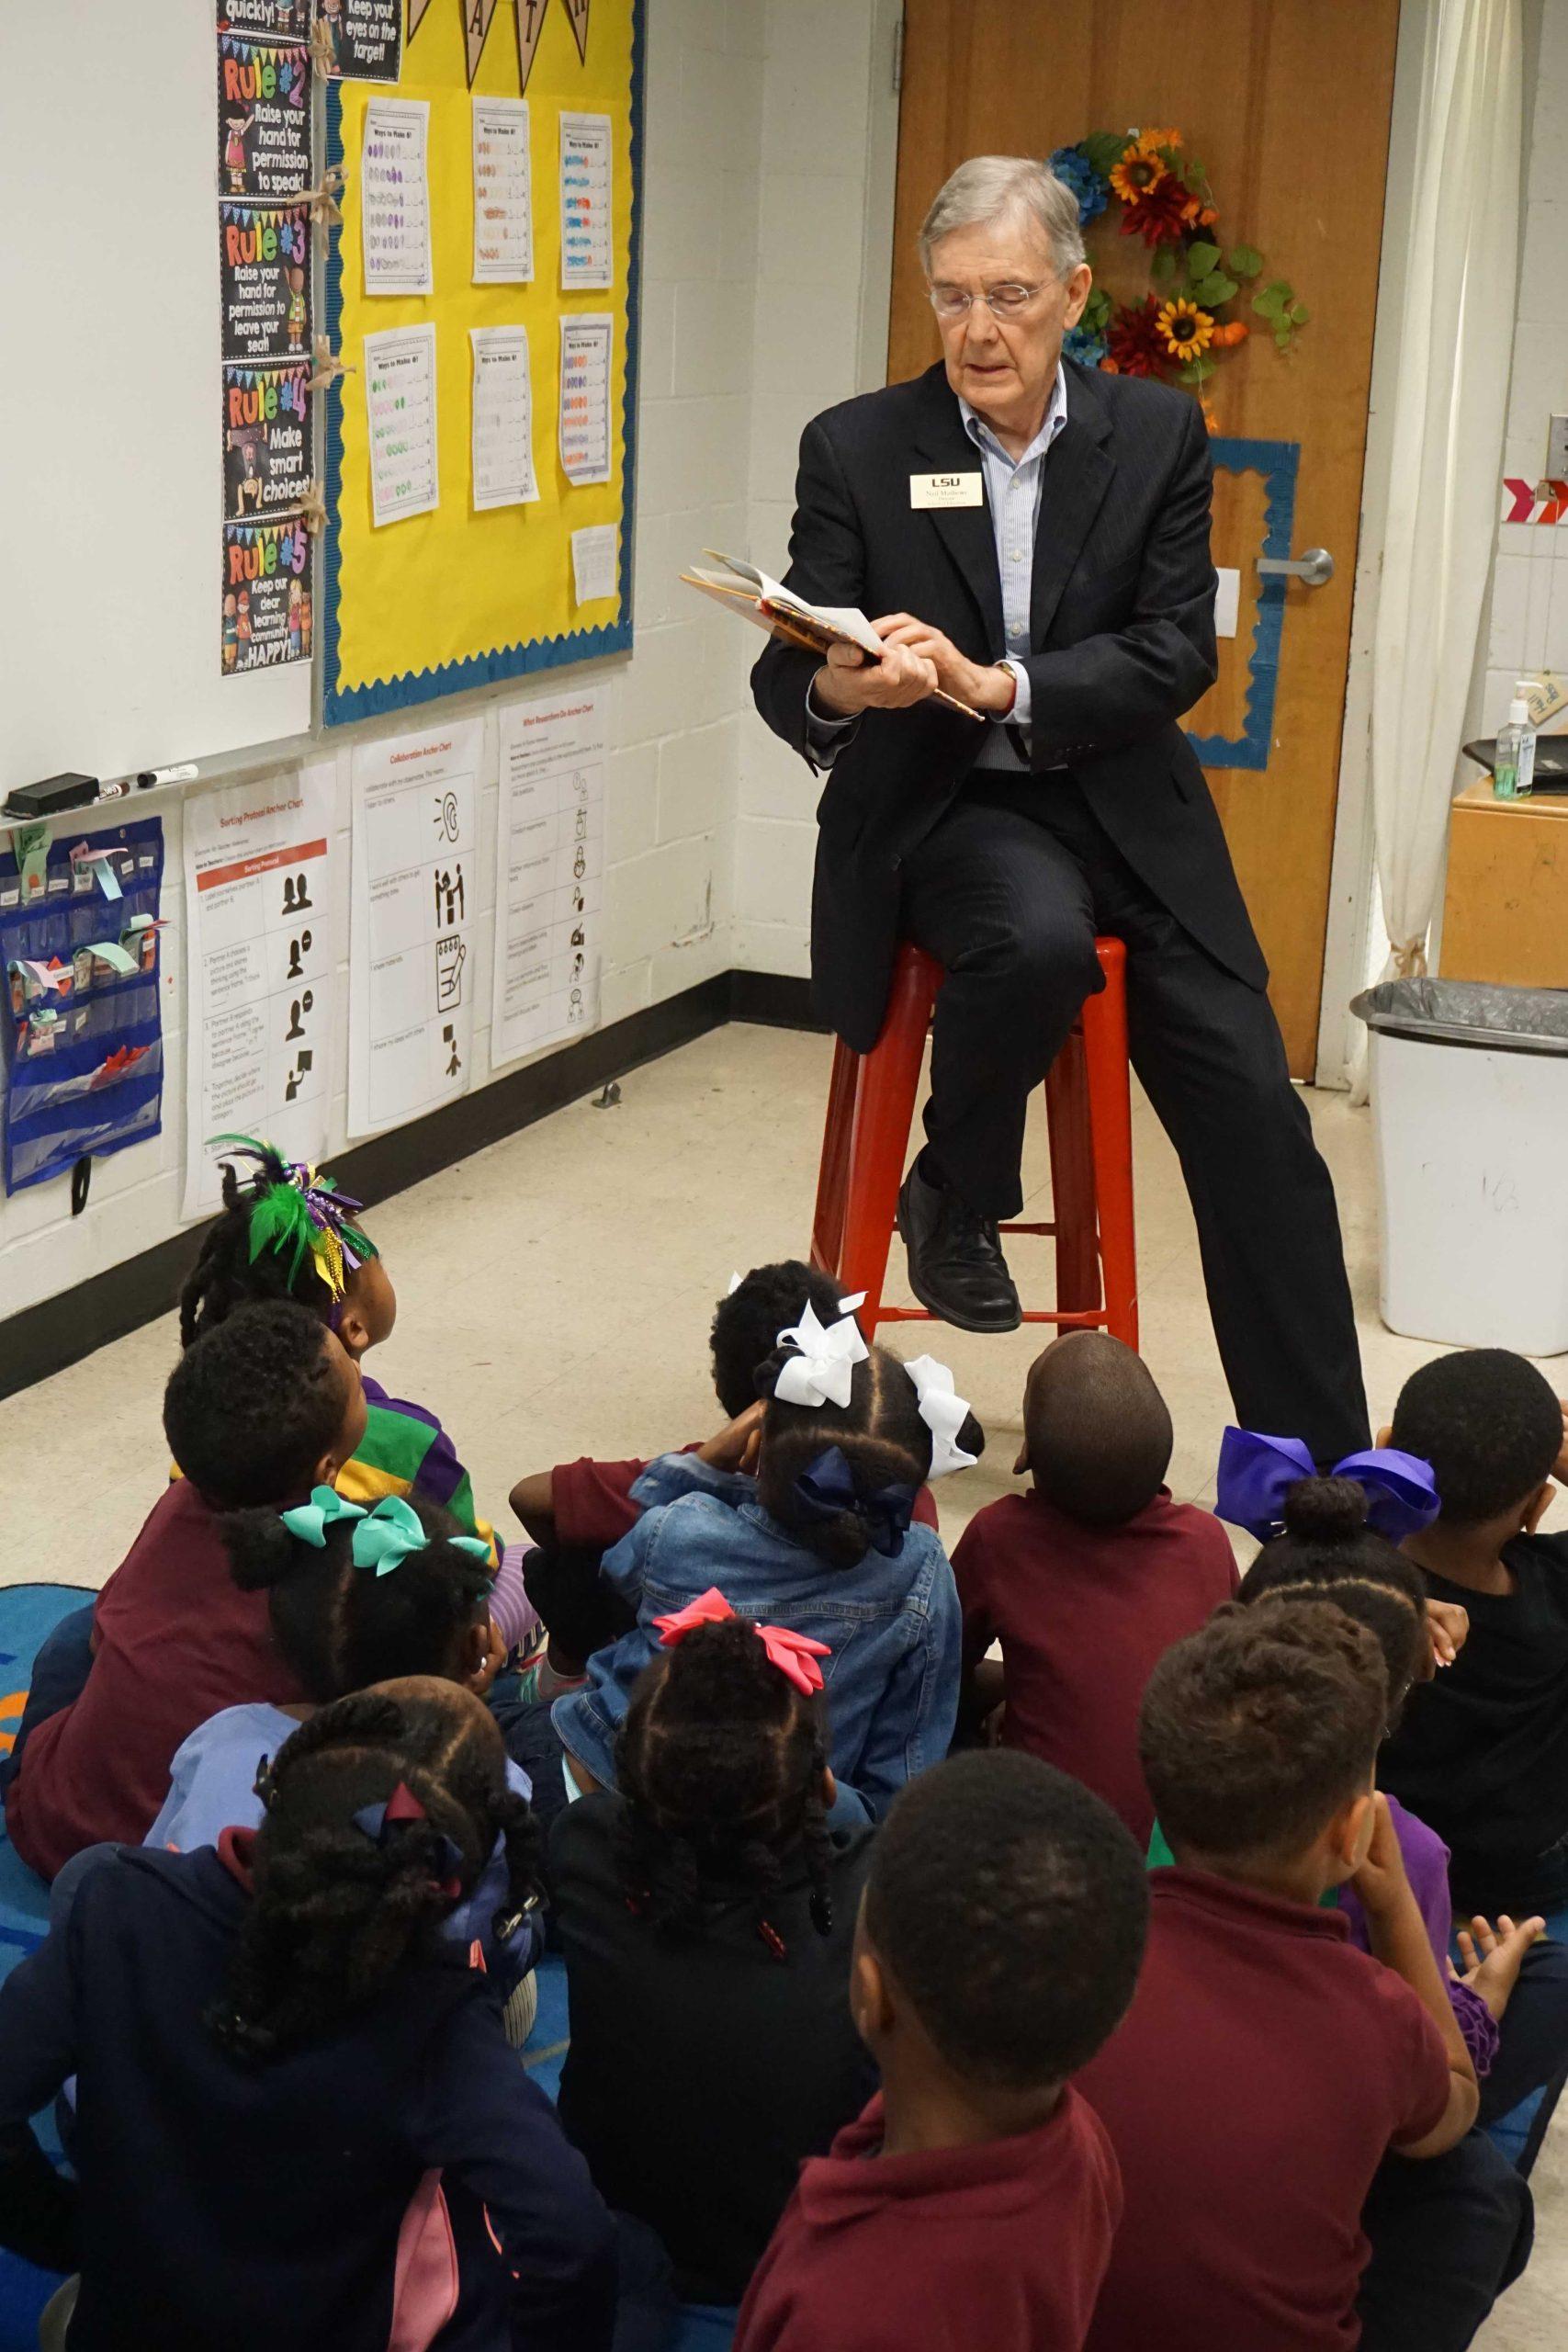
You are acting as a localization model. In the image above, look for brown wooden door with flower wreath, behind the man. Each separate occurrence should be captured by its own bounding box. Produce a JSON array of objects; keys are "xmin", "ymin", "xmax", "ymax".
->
[{"xmin": 888, "ymin": 0, "xmax": 1399, "ymax": 1077}]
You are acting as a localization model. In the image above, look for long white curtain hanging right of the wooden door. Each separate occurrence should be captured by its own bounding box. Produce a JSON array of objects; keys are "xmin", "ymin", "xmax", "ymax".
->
[{"xmin": 1371, "ymin": 0, "xmax": 1523, "ymax": 1081}]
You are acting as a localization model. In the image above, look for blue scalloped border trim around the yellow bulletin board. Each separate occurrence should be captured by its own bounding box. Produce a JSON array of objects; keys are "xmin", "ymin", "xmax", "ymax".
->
[{"xmin": 322, "ymin": 0, "xmax": 647, "ymax": 727}]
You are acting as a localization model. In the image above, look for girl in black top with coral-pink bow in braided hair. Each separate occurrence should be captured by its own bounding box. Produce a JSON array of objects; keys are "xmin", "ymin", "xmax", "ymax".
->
[{"xmin": 550, "ymin": 1595, "xmax": 874, "ymax": 2302}]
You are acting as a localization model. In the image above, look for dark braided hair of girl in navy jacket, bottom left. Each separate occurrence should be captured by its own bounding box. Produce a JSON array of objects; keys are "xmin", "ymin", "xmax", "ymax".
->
[{"xmin": 207, "ymin": 1687, "xmax": 538, "ymax": 2065}]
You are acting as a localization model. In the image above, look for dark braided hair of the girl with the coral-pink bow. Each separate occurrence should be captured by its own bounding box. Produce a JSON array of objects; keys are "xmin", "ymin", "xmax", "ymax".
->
[{"xmin": 616, "ymin": 1618, "xmax": 832, "ymax": 1959}]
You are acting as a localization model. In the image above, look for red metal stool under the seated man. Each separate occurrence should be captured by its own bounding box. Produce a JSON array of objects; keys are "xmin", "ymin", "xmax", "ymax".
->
[{"xmin": 811, "ymin": 938, "xmax": 1138, "ymax": 1348}]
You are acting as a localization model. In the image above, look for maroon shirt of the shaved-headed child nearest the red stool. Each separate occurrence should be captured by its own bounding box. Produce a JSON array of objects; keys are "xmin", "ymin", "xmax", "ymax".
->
[{"xmin": 952, "ymin": 1488, "xmax": 1239, "ymax": 1847}]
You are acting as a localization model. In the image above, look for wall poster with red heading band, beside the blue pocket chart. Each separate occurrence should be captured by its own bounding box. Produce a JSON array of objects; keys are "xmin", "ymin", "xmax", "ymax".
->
[{"xmin": 181, "ymin": 760, "xmax": 339, "ymax": 1216}]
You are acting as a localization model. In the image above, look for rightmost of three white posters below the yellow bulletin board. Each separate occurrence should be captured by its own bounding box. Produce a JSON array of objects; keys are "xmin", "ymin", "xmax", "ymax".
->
[{"xmin": 491, "ymin": 689, "xmax": 604, "ymax": 1063}]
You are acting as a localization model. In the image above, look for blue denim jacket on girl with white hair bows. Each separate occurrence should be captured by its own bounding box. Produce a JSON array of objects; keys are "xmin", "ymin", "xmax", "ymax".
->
[{"xmin": 550, "ymin": 1453, "xmax": 962, "ymax": 1818}]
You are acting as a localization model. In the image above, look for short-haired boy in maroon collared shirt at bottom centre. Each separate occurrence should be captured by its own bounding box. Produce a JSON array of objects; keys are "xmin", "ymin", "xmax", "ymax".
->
[{"xmin": 736, "ymin": 1755, "xmax": 1146, "ymax": 2352}]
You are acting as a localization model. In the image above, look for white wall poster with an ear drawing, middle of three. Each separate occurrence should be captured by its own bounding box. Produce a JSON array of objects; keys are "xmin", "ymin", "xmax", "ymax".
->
[{"xmin": 348, "ymin": 719, "xmax": 484, "ymax": 1136}]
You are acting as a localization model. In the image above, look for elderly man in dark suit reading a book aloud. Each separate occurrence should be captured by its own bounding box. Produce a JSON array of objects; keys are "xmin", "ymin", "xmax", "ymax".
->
[{"xmin": 752, "ymin": 155, "xmax": 1368, "ymax": 1458}]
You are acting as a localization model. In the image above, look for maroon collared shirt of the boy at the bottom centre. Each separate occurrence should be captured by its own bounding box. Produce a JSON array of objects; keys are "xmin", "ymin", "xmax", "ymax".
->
[{"xmin": 733, "ymin": 2086, "xmax": 1114, "ymax": 2352}]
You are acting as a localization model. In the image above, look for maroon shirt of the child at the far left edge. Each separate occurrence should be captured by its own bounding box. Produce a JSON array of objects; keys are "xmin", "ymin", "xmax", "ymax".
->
[{"xmin": 5, "ymin": 1479, "xmax": 306, "ymax": 1879}]
